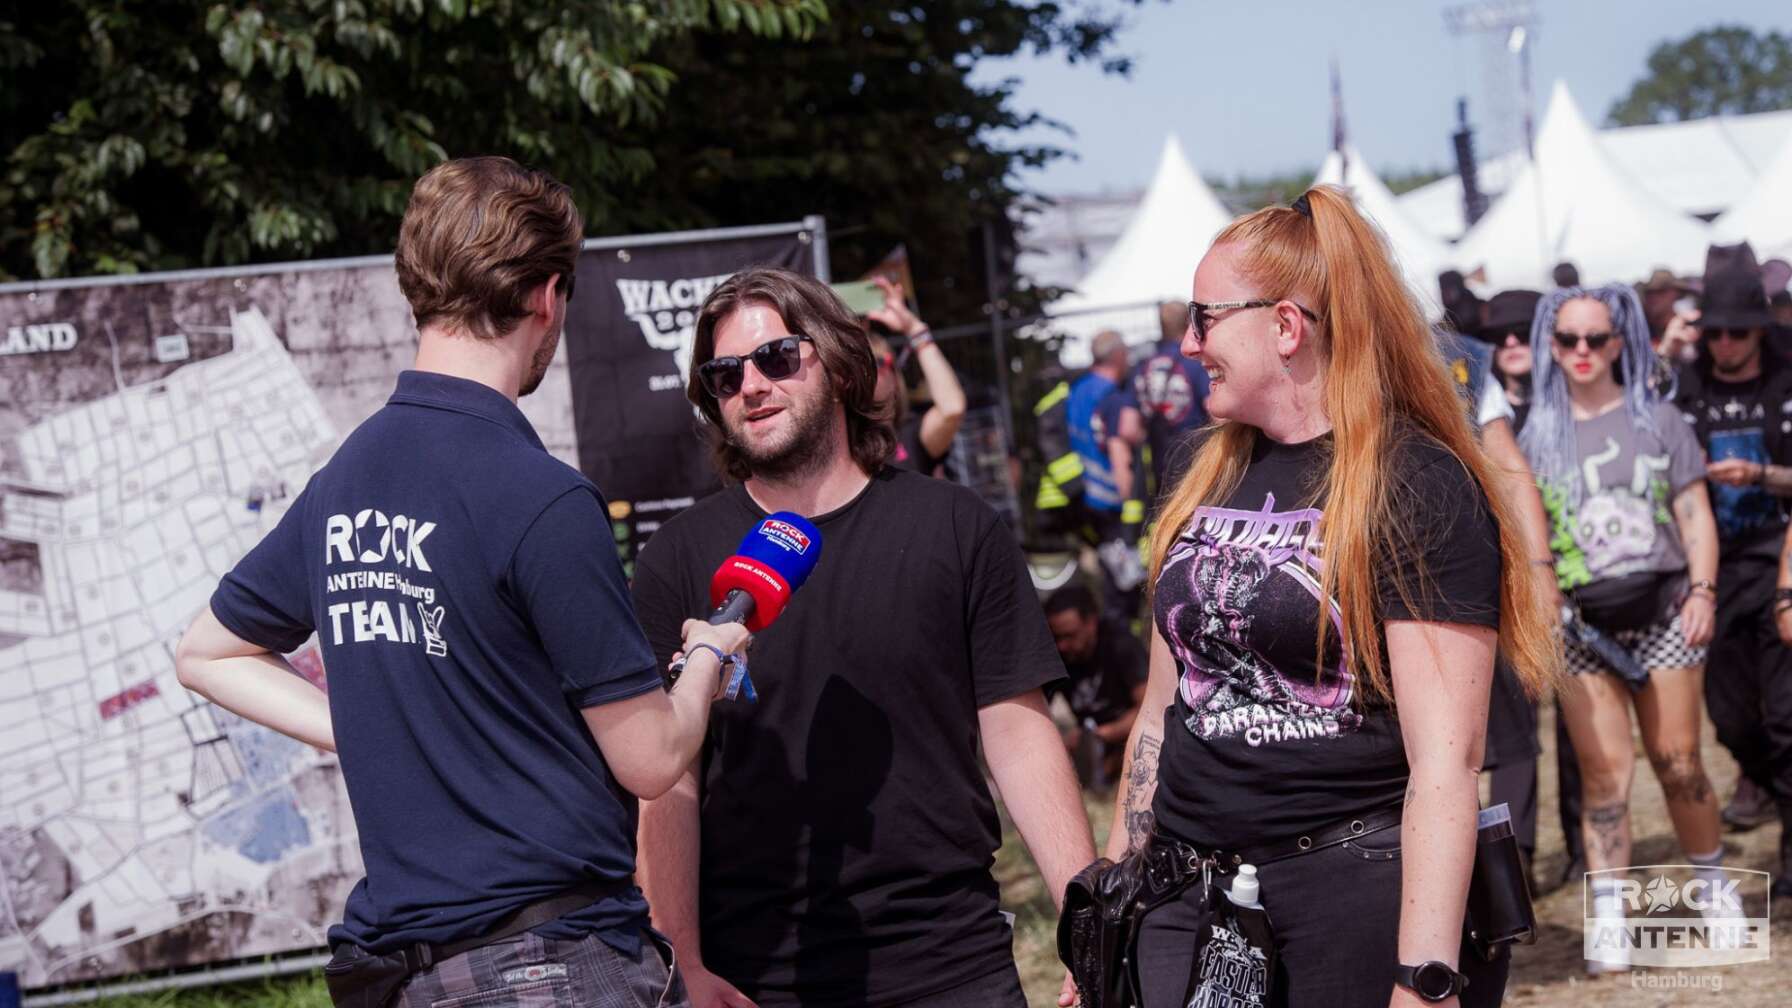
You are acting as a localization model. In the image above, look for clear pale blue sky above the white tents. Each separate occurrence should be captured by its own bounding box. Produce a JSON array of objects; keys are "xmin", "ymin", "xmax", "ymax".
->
[{"xmin": 977, "ymin": 0, "xmax": 1792, "ymax": 194}]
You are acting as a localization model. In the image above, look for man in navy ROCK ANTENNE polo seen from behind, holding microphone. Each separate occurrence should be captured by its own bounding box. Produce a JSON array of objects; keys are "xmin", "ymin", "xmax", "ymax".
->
[{"xmin": 177, "ymin": 158, "xmax": 747, "ymax": 1004}]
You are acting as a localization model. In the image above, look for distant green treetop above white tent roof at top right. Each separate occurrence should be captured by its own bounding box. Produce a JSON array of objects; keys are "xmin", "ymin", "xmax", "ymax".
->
[{"xmin": 1606, "ymin": 25, "xmax": 1792, "ymax": 126}]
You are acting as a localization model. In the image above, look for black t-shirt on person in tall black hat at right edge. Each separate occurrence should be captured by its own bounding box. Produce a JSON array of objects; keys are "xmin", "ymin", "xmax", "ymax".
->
[{"xmin": 1679, "ymin": 371, "xmax": 1792, "ymax": 561}]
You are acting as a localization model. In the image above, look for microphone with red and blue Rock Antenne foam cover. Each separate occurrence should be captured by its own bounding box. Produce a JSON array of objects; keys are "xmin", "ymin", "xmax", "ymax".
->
[{"xmin": 688, "ymin": 511, "xmax": 821, "ymax": 703}]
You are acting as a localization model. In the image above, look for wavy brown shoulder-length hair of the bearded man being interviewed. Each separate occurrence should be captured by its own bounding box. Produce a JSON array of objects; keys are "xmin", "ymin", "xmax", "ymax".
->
[{"xmin": 685, "ymin": 267, "xmax": 896, "ymax": 481}]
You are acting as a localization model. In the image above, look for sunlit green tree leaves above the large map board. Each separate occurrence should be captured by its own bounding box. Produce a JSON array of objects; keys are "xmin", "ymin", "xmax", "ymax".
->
[{"xmin": 0, "ymin": 0, "xmax": 826, "ymax": 276}]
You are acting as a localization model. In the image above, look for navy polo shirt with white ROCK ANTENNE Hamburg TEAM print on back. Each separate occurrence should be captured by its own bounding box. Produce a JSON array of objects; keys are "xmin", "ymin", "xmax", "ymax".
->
[{"xmin": 211, "ymin": 371, "xmax": 659, "ymax": 956}]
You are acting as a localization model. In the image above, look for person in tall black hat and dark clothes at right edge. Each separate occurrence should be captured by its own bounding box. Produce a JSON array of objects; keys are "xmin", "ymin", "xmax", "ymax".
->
[{"xmin": 1679, "ymin": 244, "xmax": 1792, "ymax": 895}]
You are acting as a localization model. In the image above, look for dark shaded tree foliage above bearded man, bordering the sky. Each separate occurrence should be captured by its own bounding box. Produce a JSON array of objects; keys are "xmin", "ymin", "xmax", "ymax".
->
[{"xmin": 584, "ymin": 0, "xmax": 1138, "ymax": 326}]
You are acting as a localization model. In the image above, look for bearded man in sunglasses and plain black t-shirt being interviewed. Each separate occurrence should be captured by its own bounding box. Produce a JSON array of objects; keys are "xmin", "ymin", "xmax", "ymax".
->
[{"xmin": 634, "ymin": 269, "xmax": 1095, "ymax": 1008}]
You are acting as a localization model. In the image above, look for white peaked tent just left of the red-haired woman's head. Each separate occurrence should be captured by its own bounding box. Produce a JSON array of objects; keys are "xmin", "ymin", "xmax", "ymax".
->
[{"xmin": 1047, "ymin": 136, "xmax": 1231, "ymax": 366}]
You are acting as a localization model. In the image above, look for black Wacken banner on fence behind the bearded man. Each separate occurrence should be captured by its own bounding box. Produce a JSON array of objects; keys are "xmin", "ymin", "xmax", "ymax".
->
[{"xmin": 566, "ymin": 228, "xmax": 819, "ymax": 576}]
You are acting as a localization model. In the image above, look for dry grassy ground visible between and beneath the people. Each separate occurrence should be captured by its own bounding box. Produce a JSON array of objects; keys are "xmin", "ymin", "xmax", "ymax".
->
[{"xmin": 59, "ymin": 703, "xmax": 1792, "ymax": 1008}]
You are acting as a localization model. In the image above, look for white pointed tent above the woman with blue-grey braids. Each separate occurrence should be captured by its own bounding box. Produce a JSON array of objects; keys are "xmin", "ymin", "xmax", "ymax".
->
[{"xmin": 1455, "ymin": 83, "xmax": 1710, "ymax": 287}]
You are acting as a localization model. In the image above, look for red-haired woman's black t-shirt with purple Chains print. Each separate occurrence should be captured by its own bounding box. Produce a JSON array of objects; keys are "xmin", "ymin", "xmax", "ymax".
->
[{"xmin": 1152, "ymin": 436, "xmax": 1500, "ymax": 847}]
